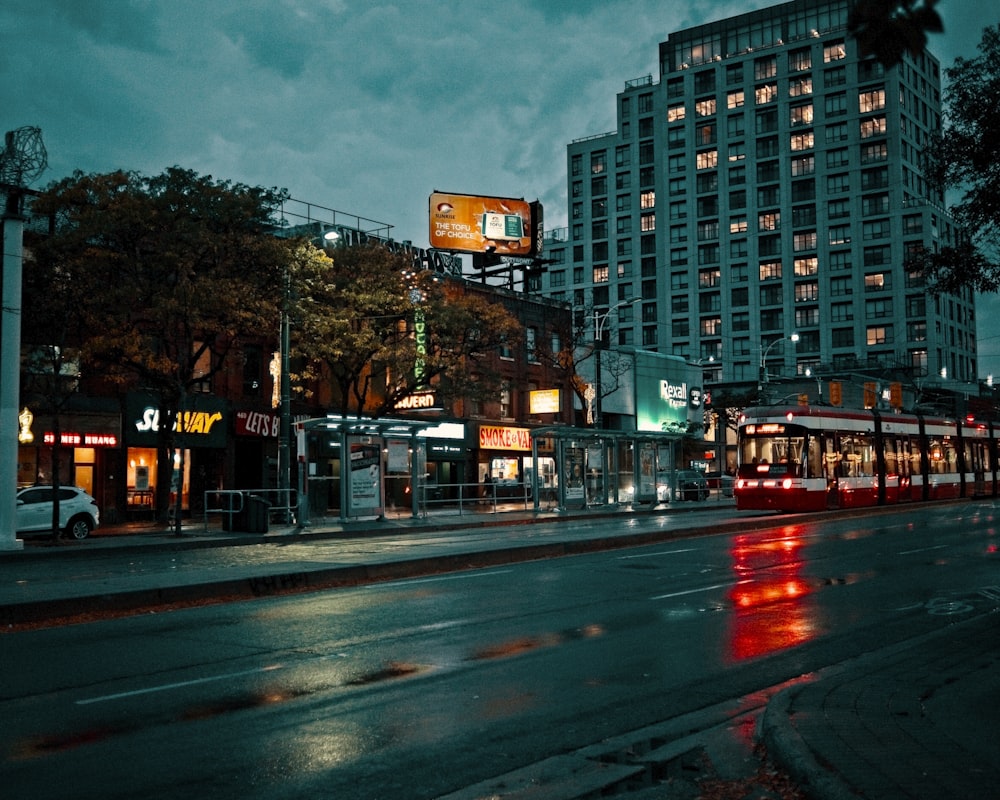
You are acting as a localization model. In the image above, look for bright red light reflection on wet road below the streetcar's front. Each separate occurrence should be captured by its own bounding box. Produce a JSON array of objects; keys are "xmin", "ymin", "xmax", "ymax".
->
[{"xmin": 728, "ymin": 526, "xmax": 816, "ymax": 661}]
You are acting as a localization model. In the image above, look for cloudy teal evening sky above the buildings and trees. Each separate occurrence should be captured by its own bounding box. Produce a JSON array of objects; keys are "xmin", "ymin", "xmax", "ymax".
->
[{"xmin": 0, "ymin": 0, "xmax": 1000, "ymax": 375}]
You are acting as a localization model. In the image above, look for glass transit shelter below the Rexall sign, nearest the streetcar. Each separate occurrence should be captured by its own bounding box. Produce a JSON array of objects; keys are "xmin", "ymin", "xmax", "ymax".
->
[{"xmin": 529, "ymin": 426, "xmax": 683, "ymax": 511}]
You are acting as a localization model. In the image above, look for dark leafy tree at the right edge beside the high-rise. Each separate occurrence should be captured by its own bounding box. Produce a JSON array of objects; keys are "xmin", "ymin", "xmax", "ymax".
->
[{"xmin": 915, "ymin": 26, "xmax": 1000, "ymax": 293}]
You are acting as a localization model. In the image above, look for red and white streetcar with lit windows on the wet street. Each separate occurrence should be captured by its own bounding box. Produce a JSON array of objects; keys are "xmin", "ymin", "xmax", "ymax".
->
[{"xmin": 734, "ymin": 406, "xmax": 998, "ymax": 511}]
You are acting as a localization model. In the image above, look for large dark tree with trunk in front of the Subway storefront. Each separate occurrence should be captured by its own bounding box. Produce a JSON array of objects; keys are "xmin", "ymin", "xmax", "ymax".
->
[{"xmin": 26, "ymin": 167, "xmax": 290, "ymax": 533}]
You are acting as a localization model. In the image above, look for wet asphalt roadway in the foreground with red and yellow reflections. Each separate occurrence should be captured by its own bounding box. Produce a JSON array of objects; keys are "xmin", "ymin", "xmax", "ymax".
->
[{"xmin": 0, "ymin": 503, "xmax": 1000, "ymax": 798}]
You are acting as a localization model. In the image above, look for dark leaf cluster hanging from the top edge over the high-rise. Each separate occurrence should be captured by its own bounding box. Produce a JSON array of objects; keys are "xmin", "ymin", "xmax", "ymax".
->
[{"xmin": 847, "ymin": 0, "xmax": 944, "ymax": 67}]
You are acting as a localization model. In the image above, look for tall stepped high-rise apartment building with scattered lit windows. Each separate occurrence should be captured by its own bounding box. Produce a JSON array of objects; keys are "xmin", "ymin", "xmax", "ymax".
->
[{"xmin": 543, "ymin": 0, "xmax": 976, "ymax": 394}]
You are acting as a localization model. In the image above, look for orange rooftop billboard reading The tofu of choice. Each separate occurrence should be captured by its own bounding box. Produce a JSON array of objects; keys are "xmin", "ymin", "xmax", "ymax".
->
[{"xmin": 428, "ymin": 192, "xmax": 542, "ymax": 258}]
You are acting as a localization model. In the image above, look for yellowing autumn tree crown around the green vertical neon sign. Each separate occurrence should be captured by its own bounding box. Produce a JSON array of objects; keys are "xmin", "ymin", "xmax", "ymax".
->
[{"xmin": 292, "ymin": 244, "xmax": 521, "ymax": 417}]
